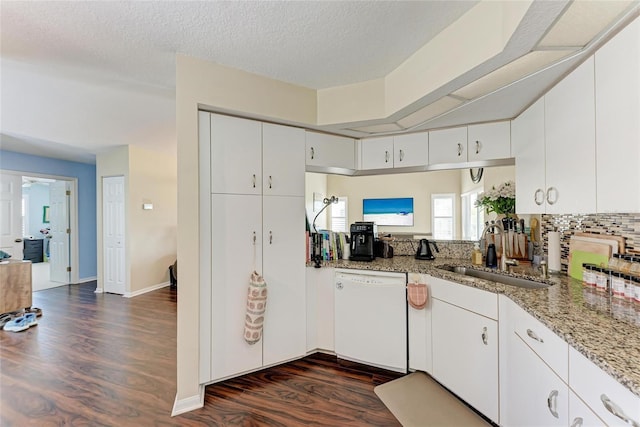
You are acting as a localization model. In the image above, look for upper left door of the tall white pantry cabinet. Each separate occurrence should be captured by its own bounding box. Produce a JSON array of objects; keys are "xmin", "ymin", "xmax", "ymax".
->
[{"xmin": 211, "ymin": 114, "xmax": 262, "ymax": 194}]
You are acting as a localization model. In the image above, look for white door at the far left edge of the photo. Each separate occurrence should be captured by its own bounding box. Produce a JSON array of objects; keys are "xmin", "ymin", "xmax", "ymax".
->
[{"xmin": 0, "ymin": 173, "xmax": 23, "ymax": 259}]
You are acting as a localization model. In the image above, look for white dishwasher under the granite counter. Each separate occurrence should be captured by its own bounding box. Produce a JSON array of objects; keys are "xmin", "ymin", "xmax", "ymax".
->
[{"xmin": 334, "ymin": 269, "xmax": 407, "ymax": 373}]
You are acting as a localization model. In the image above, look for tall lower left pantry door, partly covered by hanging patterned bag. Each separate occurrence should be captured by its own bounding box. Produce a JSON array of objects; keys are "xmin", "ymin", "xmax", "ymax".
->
[{"xmin": 211, "ymin": 194, "xmax": 262, "ymax": 381}]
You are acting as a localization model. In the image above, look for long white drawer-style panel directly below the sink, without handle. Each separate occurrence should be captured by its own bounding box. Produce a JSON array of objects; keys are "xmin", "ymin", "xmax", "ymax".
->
[{"xmin": 429, "ymin": 276, "xmax": 498, "ymax": 320}]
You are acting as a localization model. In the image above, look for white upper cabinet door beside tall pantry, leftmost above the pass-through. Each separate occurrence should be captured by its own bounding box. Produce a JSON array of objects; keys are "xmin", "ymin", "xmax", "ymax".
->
[{"xmin": 305, "ymin": 131, "xmax": 356, "ymax": 170}]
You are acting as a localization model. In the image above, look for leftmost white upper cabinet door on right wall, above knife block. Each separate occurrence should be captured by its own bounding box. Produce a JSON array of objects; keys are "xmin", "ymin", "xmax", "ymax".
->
[{"xmin": 511, "ymin": 97, "xmax": 547, "ymax": 214}]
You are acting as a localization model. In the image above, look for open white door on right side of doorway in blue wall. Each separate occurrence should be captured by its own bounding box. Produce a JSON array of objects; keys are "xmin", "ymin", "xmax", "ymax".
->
[{"xmin": 45, "ymin": 181, "xmax": 71, "ymax": 283}]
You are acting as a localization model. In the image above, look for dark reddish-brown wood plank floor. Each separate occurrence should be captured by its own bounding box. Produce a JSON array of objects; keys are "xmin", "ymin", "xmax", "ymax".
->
[{"xmin": 0, "ymin": 283, "xmax": 399, "ymax": 426}]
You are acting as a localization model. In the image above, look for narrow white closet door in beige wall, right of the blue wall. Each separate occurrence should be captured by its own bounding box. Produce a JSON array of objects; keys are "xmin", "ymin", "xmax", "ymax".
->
[{"xmin": 102, "ymin": 176, "xmax": 126, "ymax": 294}]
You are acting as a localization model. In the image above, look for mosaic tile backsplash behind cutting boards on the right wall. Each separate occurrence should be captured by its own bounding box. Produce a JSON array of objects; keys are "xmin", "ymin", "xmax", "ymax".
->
[{"xmin": 541, "ymin": 214, "xmax": 640, "ymax": 270}]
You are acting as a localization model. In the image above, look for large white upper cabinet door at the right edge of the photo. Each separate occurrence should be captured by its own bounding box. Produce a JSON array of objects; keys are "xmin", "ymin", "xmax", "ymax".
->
[{"xmin": 595, "ymin": 18, "xmax": 640, "ymax": 213}]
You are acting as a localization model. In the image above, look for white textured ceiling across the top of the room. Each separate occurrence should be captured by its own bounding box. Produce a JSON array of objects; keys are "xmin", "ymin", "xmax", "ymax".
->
[{"xmin": 1, "ymin": 1, "xmax": 477, "ymax": 89}]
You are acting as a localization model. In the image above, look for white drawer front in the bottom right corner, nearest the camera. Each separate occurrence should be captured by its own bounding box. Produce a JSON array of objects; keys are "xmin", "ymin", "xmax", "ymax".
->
[{"xmin": 569, "ymin": 348, "xmax": 640, "ymax": 426}]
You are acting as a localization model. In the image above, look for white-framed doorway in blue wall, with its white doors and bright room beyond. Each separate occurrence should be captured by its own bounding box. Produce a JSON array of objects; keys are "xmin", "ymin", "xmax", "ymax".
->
[{"xmin": 0, "ymin": 170, "xmax": 78, "ymax": 291}]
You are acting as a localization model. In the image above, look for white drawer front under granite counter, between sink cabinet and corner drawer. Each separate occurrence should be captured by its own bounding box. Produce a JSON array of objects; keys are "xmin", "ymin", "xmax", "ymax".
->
[{"xmin": 511, "ymin": 304, "xmax": 569, "ymax": 382}]
